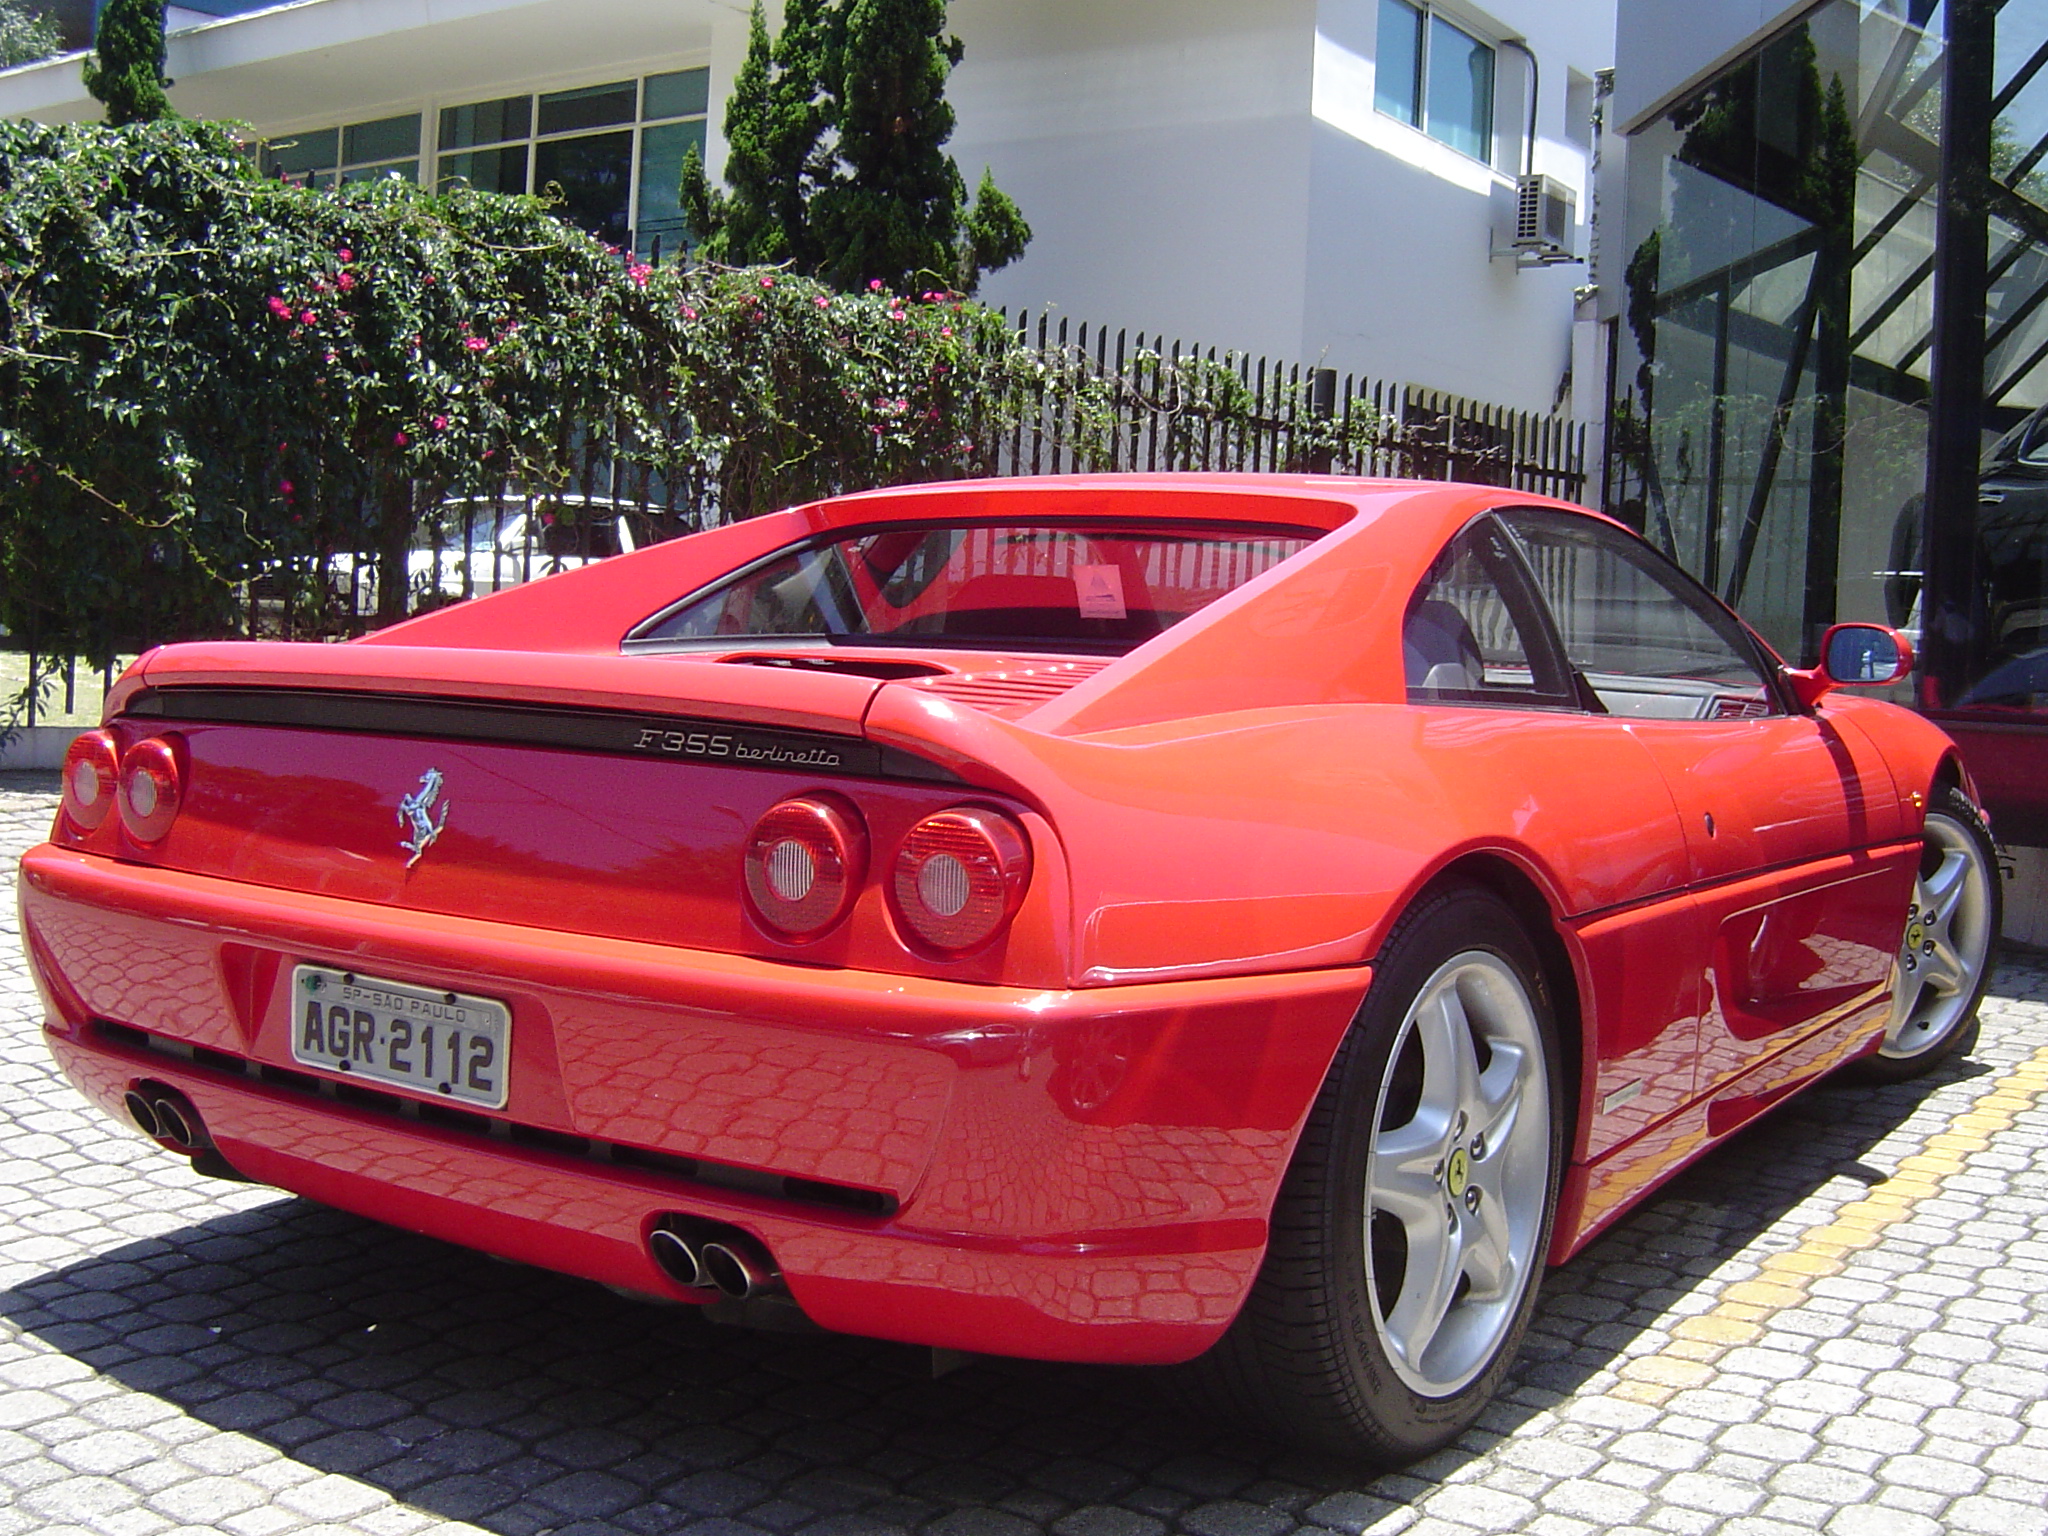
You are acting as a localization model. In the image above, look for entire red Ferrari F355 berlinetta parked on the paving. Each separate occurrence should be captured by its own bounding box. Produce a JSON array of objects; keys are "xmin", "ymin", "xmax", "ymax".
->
[{"xmin": 20, "ymin": 475, "xmax": 1999, "ymax": 1458}]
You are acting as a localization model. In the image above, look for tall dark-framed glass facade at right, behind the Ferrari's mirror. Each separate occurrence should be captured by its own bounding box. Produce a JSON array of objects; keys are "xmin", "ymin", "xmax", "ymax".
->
[{"xmin": 1602, "ymin": 0, "xmax": 2048, "ymax": 842}]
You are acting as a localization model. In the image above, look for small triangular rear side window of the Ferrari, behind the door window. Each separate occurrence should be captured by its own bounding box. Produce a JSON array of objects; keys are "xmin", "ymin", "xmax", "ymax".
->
[{"xmin": 1401, "ymin": 518, "xmax": 1573, "ymax": 707}]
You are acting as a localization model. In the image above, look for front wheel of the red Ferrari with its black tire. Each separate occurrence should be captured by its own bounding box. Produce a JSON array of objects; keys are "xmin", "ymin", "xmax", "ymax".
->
[{"xmin": 1847, "ymin": 784, "xmax": 2005, "ymax": 1083}]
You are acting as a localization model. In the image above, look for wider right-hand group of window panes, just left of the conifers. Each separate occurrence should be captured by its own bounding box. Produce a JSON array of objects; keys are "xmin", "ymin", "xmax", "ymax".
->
[{"xmin": 434, "ymin": 70, "xmax": 711, "ymax": 256}]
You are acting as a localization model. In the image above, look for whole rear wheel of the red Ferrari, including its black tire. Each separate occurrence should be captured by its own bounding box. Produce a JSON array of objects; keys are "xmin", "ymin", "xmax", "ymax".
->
[{"xmin": 1182, "ymin": 885, "xmax": 1567, "ymax": 1464}]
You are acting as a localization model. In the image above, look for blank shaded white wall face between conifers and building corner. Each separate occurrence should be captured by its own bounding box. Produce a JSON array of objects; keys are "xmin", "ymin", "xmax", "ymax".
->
[{"xmin": 948, "ymin": 0, "xmax": 1315, "ymax": 366}]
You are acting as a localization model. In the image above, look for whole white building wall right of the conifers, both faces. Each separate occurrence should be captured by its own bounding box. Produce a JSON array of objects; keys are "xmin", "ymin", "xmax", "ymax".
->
[{"xmin": 950, "ymin": 0, "xmax": 1614, "ymax": 416}]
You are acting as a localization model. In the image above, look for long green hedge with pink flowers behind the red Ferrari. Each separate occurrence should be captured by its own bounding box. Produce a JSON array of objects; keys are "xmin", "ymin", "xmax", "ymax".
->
[{"xmin": 0, "ymin": 121, "xmax": 1036, "ymax": 657}]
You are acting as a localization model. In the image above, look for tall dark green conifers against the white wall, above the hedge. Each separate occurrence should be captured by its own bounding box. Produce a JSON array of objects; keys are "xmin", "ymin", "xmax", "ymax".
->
[{"xmin": 682, "ymin": 0, "xmax": 1030, "ymax": 293}]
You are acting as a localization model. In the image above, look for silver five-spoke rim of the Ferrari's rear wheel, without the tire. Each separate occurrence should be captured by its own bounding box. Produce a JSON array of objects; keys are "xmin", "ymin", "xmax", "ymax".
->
[{"xmin": 1364, "ymin": 950, "xmax": 1550, "ymax": 1397}]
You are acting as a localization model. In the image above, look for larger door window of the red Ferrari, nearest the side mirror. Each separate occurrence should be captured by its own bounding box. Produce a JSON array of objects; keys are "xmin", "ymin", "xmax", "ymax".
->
[{"xmin": 1501, "ymin": 508, "xmax": 1780, "ymax": 721}]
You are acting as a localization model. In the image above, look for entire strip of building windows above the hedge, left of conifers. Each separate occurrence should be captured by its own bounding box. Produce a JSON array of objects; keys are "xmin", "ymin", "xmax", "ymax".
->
[{"xmin": 262, "ymin": 70, "xmax": 711, "ymax": 256}]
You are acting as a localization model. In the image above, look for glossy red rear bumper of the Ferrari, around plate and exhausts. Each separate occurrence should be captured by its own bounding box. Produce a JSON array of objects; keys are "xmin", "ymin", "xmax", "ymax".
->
[{"xmin": 20, "ymin": 846, "xmax": 1368, "ymax": 1362}]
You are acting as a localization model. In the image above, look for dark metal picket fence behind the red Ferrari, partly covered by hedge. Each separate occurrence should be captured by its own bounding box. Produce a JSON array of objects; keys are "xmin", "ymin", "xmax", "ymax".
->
[{"xmin": 14, "ymin": 313, "xmax": 1585, "ymax": 725}]
